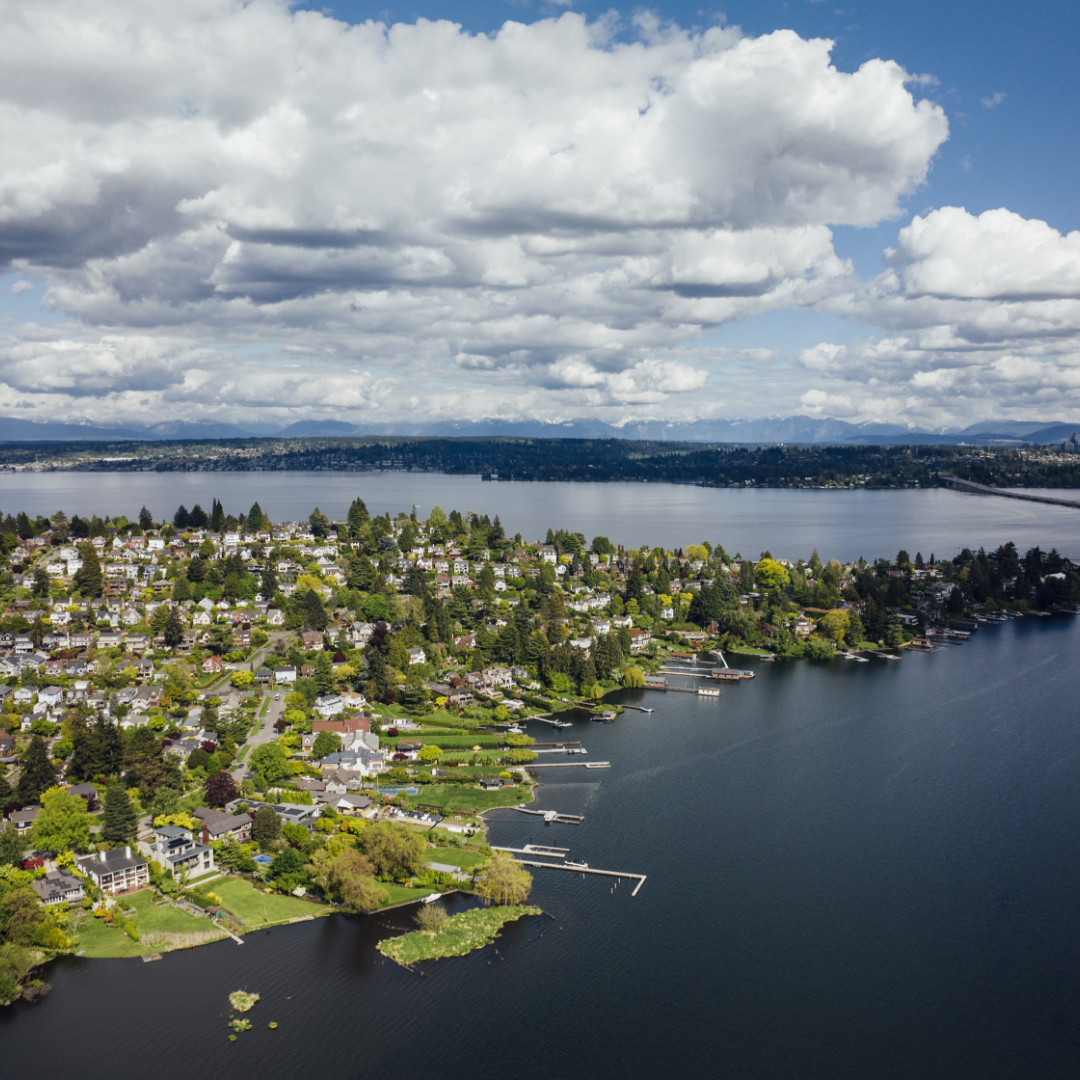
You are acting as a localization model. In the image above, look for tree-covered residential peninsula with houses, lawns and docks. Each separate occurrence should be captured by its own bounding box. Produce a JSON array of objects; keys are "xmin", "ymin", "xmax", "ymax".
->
[{"xmin": 0, "ymin": 498, "xmax": 1080, "ymax": 1002}]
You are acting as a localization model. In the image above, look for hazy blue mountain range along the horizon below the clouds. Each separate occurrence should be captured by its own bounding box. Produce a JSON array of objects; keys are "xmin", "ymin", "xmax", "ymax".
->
[{"xmin": 0, "ymin": 416, "xmax": 1080, "ymax": 446}]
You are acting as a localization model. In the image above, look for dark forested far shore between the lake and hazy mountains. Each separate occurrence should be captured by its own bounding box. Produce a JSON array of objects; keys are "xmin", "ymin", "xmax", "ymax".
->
[{"xmin": 0, "ymin": 436, "xmax": 1080, "ymax": 488}]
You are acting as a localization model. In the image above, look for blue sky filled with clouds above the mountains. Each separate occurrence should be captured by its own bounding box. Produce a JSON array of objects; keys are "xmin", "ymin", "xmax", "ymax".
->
[{"xmin": 0, "ymin": 0, "xmax": 1080, "ymax": 429}]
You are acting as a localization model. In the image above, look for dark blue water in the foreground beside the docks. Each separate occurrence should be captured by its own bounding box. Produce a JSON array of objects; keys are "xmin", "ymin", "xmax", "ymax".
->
[{"xmin": 8, "ymin": 619, "xmax": 1080, "ymax": 1080}]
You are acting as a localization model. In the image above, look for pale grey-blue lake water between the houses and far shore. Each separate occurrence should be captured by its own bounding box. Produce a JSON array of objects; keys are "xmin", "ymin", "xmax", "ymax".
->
[{"xmin": 0, "ymin": 472, "xmax": 1080, "ymax": 562}]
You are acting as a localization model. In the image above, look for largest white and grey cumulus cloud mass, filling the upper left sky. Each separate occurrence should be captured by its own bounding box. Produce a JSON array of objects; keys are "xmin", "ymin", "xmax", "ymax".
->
[{"xmin": 0, "ymin": 0, "xmax": 948, "ymax": 419}]
